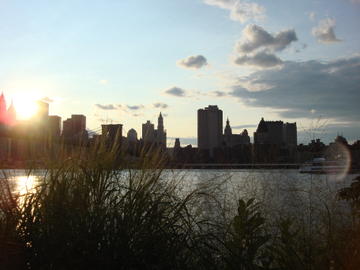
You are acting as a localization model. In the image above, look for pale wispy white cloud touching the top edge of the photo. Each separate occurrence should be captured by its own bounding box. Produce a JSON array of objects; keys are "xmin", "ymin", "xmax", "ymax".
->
[{"xmin": 204, "ymin": 0, "xmax": 266, "ymax": 23}]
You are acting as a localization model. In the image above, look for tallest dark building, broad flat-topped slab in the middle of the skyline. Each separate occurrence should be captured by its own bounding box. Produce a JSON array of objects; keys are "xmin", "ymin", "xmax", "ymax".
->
[{"xmin": 198, "ymin": 105, "xmax": 223, "ymax": 152}]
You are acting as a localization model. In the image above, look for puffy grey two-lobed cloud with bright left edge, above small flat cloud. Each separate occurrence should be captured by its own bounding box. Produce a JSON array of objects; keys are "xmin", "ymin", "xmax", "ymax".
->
[{"xmin": 236, "ymin": 24, "xmax": 298, "ymax": 54}]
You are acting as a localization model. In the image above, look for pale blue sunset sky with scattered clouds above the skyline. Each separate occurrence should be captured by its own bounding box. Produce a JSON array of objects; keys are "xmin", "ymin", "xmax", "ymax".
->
[{"xmin": 0, "ymin": 0, "xmax": 360, "ymax": 145}]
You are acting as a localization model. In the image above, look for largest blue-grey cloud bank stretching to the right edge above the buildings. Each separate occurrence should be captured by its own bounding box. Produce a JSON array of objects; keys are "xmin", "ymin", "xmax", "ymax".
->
[{"xmin": 229, "ymin": 56, "xmax": 360, "ymax": 122}]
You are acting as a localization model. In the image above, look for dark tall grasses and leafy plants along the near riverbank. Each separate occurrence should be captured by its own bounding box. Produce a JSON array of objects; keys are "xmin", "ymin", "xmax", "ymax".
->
[{"xmin": 0, "ymin": 141, "xmax": 360, "ymax": 270}]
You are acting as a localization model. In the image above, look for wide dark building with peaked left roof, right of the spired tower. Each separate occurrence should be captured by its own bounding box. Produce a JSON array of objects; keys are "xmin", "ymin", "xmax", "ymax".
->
[{"xmin": 254, "ymin": 118, "xmax": 297, "ymax": 146}]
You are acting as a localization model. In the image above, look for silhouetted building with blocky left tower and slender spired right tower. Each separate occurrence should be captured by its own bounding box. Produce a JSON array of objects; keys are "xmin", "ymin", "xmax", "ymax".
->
[{"xmin": 142, "ymin": 113, "xmax": 166, "ymax": 148}]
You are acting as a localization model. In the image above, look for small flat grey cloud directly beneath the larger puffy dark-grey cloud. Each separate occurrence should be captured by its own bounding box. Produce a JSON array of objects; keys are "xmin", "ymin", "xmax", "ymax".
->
[{"xmin": 234, "ymin": 52, "xmax": 283, "ymax": 68}]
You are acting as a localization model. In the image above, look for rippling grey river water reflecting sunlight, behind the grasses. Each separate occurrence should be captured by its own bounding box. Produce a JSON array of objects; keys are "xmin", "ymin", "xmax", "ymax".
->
[{"xmin": 3, "ymin": 169, "xmax": 357, "ymax": 224}]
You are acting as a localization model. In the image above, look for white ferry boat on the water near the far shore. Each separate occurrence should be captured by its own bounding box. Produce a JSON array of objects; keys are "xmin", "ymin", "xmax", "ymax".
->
[{"xmin": 299, "ymin": 158, "xmax": 348, "ymax": 174}]
